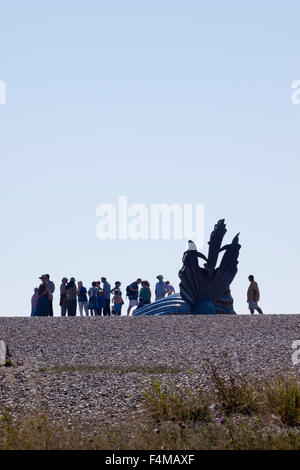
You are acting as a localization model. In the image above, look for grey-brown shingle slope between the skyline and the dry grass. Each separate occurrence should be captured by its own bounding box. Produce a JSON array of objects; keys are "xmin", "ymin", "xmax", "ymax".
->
[{"xmin": 0, "ymin": 315, "xmax": 300, "ymax": 430}]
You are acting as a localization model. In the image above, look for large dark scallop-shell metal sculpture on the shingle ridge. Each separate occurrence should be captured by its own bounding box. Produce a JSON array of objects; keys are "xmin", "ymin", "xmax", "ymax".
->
[{"xmin": 134, "ymin": 219, "xmax": 241, "ymax": 316}]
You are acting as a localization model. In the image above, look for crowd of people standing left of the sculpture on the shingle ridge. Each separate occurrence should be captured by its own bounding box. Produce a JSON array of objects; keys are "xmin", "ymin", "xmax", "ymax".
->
[{"xmin": 31, "ymin": 274, "xmax": 175, "ymax": 317}]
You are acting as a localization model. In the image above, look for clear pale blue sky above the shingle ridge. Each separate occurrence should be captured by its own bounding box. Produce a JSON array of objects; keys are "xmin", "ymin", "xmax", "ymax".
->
[{"xmin": 0, "ymin": 0, "xmax": 300, "ymax": 316}]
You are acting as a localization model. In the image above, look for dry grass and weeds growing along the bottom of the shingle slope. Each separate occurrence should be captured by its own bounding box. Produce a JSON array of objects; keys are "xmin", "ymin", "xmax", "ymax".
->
[{"xmin": 0, "ymin": 363, "xmax": 300, "ymax": 450}]
